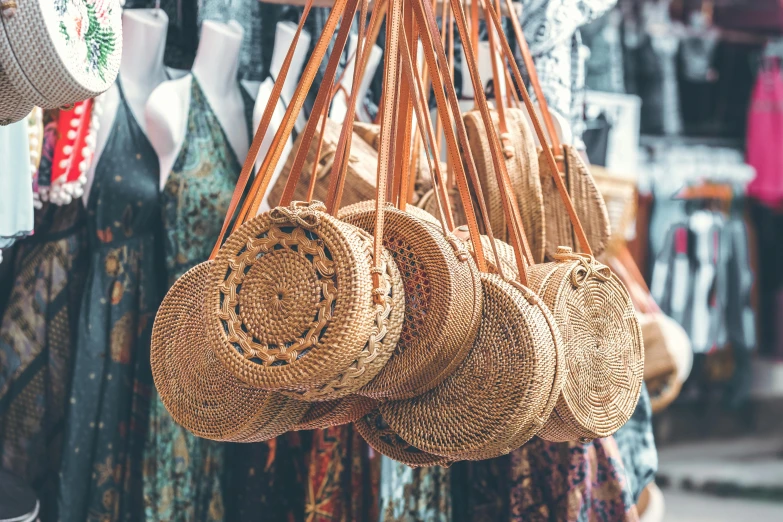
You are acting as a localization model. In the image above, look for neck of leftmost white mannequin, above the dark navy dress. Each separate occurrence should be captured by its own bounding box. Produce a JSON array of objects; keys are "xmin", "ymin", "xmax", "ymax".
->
[{"xmin": 120, "ymin": 9, "xmax": 169, "ymax": 91}]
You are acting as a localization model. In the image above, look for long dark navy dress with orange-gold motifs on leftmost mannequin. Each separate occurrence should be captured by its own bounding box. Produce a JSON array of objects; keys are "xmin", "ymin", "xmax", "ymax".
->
[{"xmin": 60, "ymin": 81, "xmax": 164, "ymax": 522}]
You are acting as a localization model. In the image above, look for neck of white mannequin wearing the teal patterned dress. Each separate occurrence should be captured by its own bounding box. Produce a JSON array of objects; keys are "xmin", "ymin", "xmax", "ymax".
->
[{"xmin": 192, "ymin": 20, "xmax": 242, "ymax": 96}]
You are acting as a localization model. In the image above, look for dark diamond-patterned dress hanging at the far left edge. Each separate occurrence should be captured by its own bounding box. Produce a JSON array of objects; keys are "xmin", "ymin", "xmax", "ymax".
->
[{"xmin": 0, "ymin": 196, "xmax": 86, "ymax": 522}]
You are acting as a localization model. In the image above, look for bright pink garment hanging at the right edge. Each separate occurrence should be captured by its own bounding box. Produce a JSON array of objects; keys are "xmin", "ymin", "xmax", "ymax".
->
[{"xmin": 747, "ymin": 60, "xmax": 783, "ymax": 207}]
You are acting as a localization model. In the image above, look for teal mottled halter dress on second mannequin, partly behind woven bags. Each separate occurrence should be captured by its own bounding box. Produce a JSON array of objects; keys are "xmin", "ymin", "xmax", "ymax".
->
[{"xmin": 144, "ymin": 77, "xmax": 253, "ymax": 522}]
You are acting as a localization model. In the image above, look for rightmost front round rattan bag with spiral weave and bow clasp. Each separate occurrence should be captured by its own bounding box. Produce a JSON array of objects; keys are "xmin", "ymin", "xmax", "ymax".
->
[{"xmin": 528, "ymin": 247, "xmax": 644, "ymax": 442}]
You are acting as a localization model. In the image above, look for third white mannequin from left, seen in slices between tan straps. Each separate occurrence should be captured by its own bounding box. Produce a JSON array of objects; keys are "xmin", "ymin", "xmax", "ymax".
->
[{"xmin": 253, "ymin": 22, "xmax": 310, "ymax": 212}]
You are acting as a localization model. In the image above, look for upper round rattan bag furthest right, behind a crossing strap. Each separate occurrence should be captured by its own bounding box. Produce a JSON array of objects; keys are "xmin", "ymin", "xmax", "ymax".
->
[{"xmin": 539, "ymin": 145, "xmax": 611, "ymax": 260}]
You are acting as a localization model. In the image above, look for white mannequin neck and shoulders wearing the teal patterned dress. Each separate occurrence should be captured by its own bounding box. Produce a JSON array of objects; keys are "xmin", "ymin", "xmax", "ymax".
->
[{"xmin": 145, "ymin": 20, "xmax": 250, "ymax": 189}]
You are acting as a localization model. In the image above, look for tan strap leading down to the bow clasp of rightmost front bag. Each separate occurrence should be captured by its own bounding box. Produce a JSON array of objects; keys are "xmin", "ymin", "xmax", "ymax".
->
[{"xmin": 487, "ymin": 0, "xmax": 593, "ymax": 255}]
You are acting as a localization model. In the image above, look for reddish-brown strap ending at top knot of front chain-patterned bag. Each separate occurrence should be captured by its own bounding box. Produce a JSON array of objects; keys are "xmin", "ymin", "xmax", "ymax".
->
[{"xmin": 280, "ymin": 0, "xmax": 358, "ymax": 207}]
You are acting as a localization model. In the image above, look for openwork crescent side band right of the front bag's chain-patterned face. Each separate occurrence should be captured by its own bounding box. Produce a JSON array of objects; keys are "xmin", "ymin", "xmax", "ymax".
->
[{"xmin": 281, "ymin": 225, "xmax": 405, "ymax": 400}]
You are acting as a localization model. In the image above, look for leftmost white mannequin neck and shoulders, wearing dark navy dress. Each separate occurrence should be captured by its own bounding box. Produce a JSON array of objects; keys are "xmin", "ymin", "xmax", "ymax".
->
[{"xmin": 83, "ymin": 9, "xmax": 169, "ymax": 205}]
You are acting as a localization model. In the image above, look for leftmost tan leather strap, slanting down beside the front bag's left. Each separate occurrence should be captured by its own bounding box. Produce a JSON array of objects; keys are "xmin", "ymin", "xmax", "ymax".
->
[{"xmin": 209, "ymin": 0, "xmax": 313, "ymax": 259}]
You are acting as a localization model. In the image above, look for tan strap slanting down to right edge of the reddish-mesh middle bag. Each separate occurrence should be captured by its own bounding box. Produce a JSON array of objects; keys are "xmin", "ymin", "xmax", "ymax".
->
[{"xmin": 411, "ymin": 0, "xmax": 489, "ymax": 272}]
